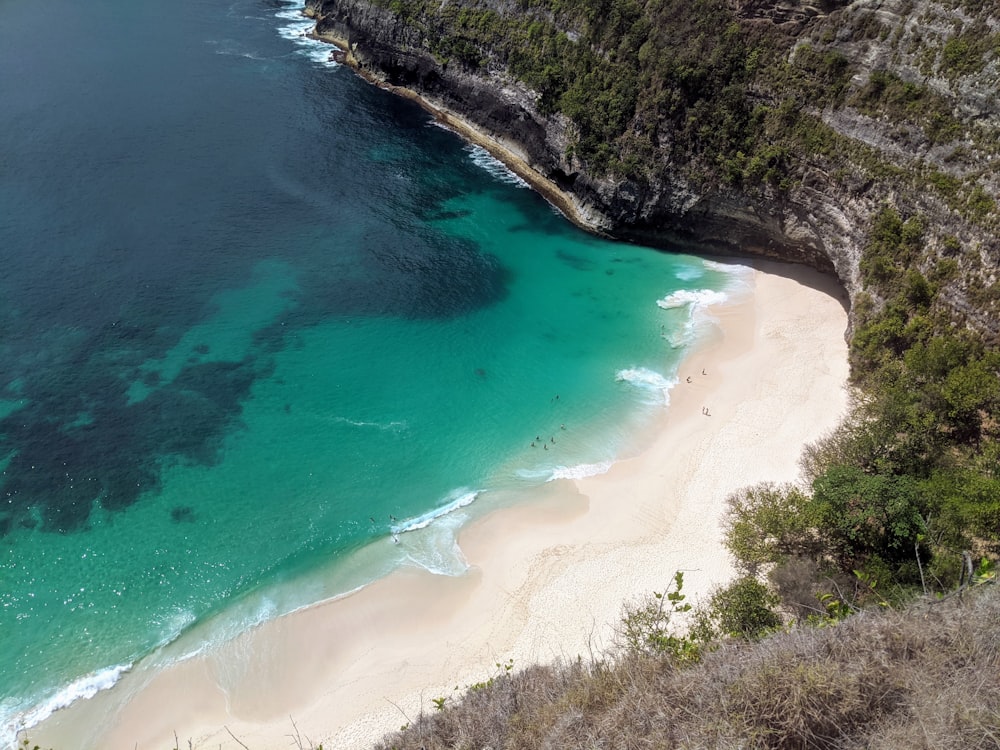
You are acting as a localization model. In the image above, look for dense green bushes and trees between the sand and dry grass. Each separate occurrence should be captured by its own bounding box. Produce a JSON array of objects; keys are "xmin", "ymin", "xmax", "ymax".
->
[{"xmin": 727, "ymin": 201, "xmax": 1000, "ymax": 616}]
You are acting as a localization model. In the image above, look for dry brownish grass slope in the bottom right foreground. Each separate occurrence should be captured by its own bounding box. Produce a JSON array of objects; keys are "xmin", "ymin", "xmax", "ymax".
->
[{"xmin": 378, "ymin": 587, "xmax": 1000, "ymax": 750}]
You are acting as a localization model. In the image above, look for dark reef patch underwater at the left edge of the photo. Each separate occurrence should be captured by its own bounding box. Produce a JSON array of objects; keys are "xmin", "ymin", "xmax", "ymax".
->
[{"xmin": 0, "ymin": 351, "xmax": 267, "ymax": 534}]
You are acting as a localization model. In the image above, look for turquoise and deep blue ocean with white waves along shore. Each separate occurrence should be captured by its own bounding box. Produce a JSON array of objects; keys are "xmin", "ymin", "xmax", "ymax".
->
[{"xmin": 0, "ymin": 0, "xmax": 746, "ymax": 746}]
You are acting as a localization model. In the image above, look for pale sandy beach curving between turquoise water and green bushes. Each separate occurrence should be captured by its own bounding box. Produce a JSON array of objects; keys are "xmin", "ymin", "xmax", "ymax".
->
[{"xmin": 32, "ymin": 262, "xmax": 847, "ymax": 750}]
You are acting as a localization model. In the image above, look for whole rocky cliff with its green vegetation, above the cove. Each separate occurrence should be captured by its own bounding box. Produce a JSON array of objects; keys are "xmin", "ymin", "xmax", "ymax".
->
[{"xmin": 306, "ymin": 0, "xmax": 1000, "ymax": 339}]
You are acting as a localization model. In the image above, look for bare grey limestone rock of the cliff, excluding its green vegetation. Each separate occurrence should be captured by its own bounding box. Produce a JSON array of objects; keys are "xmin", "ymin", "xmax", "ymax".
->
[{"xmin": 306, "ymin": 0, "xmax": 1000, "ymax": 335}]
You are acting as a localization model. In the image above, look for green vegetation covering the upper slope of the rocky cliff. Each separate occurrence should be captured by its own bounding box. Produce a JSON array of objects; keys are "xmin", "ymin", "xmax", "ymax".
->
[{"xmin": 368, "ymin": 0, "xmax": 1000, "ymax": 218}]
